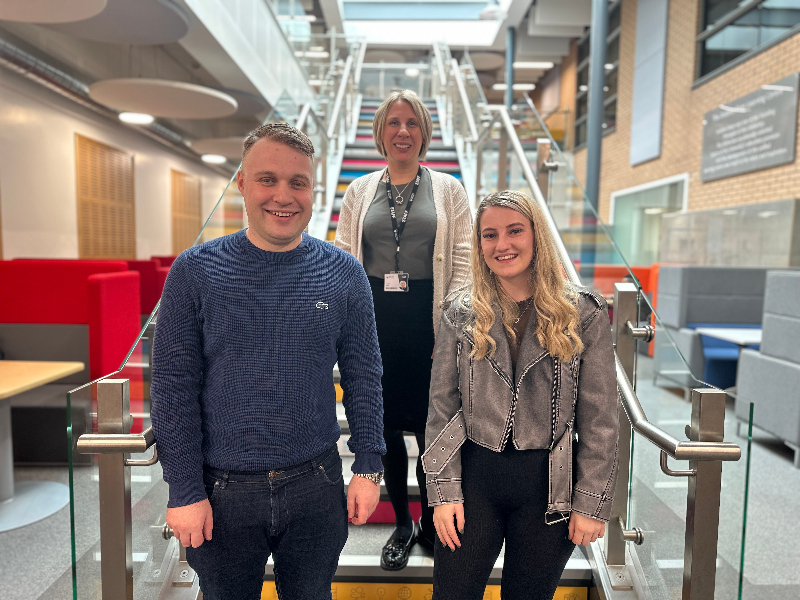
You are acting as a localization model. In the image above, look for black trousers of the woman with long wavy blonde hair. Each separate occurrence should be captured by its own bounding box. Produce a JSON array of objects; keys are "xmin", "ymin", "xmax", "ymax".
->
[{"xmin": 433, "ymin": 440, "xmax": 575, "ymax": 600}]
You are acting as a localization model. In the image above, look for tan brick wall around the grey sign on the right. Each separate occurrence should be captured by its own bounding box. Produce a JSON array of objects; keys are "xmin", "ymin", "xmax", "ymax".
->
[{"xmin": 575, "ymin": 0, "xmax": 800, "ymax": 220}]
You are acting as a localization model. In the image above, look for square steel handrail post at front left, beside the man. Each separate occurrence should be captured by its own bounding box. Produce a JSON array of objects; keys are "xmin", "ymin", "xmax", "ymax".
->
[{"xmin": 97, "ymin": 379, "xmax": 133, "ymax": 600}]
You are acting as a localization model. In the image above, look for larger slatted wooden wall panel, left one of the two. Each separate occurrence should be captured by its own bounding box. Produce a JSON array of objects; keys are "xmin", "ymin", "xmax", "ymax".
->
[{"xmin": 75, "ymin": 134, "xmax": 136, "ymax": 259}]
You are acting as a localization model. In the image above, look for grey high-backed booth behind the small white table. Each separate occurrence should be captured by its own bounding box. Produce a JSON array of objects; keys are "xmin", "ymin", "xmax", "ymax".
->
[{"xmin": 653, "ymin": 265, "xmax": 767, "ymax": 389}]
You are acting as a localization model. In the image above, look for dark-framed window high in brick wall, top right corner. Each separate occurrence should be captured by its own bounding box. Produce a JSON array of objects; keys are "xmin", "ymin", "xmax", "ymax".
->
[{"xmin": 697, "ymin": 0, "xmax": 800, "ymax": 77}]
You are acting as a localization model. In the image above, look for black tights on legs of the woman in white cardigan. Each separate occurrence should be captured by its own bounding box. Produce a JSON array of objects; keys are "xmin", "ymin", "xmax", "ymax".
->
[{"xmin": 383, "ymin": 428, "xmax": 435, "ymax": 538}]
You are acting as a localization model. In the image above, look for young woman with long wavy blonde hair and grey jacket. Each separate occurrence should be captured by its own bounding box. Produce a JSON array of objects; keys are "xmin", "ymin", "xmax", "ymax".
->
[{"xmin": 422, "ymin": 191, "xmax": 618, "ymax": 600}]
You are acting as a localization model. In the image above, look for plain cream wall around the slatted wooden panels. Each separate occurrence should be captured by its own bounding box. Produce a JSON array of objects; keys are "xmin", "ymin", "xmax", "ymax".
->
[{"xmin": 0, "ymin": 69, "xmax": 227, "ymax": 259}]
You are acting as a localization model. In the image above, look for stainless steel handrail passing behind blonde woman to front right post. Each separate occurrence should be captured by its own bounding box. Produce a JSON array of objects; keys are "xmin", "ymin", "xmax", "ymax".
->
[{"xmin": 482, "ymin": 106, "xmax": 742, "ymax": 461}]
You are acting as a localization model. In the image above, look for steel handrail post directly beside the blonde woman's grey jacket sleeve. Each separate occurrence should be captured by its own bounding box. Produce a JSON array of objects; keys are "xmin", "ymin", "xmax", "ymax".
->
[{"xmin": 605, "ymin": 283, "xmax": 639, "ymax": 589}]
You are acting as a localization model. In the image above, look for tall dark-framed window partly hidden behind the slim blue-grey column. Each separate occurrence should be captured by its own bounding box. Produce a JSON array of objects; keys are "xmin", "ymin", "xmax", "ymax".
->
[{"xmin": 575, "ymin": 0, "xmax": 620, "ymax": 146}]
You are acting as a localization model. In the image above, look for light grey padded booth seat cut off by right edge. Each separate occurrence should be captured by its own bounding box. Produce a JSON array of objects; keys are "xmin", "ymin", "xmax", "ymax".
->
[{"xmin": 736, "ymin": 271, "xmax": 800, "ymax": 468}]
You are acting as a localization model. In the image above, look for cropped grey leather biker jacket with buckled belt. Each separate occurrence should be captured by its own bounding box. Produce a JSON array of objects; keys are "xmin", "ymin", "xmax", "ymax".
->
[{"xmin": 422, "ymin": 289, "xmax": 619, "ymax": 522}]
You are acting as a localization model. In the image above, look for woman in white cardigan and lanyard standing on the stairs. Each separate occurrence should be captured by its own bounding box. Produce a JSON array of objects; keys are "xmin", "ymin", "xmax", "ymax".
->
[{"xmin": 335, "ymin": 90, "xmax": 472, "ymax": 570}]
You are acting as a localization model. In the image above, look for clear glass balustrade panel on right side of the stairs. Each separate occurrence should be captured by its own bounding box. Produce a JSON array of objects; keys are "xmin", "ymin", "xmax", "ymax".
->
[{"xmin": 520, "ymin": 96, "xmax": 755, "ymax": 598}]
